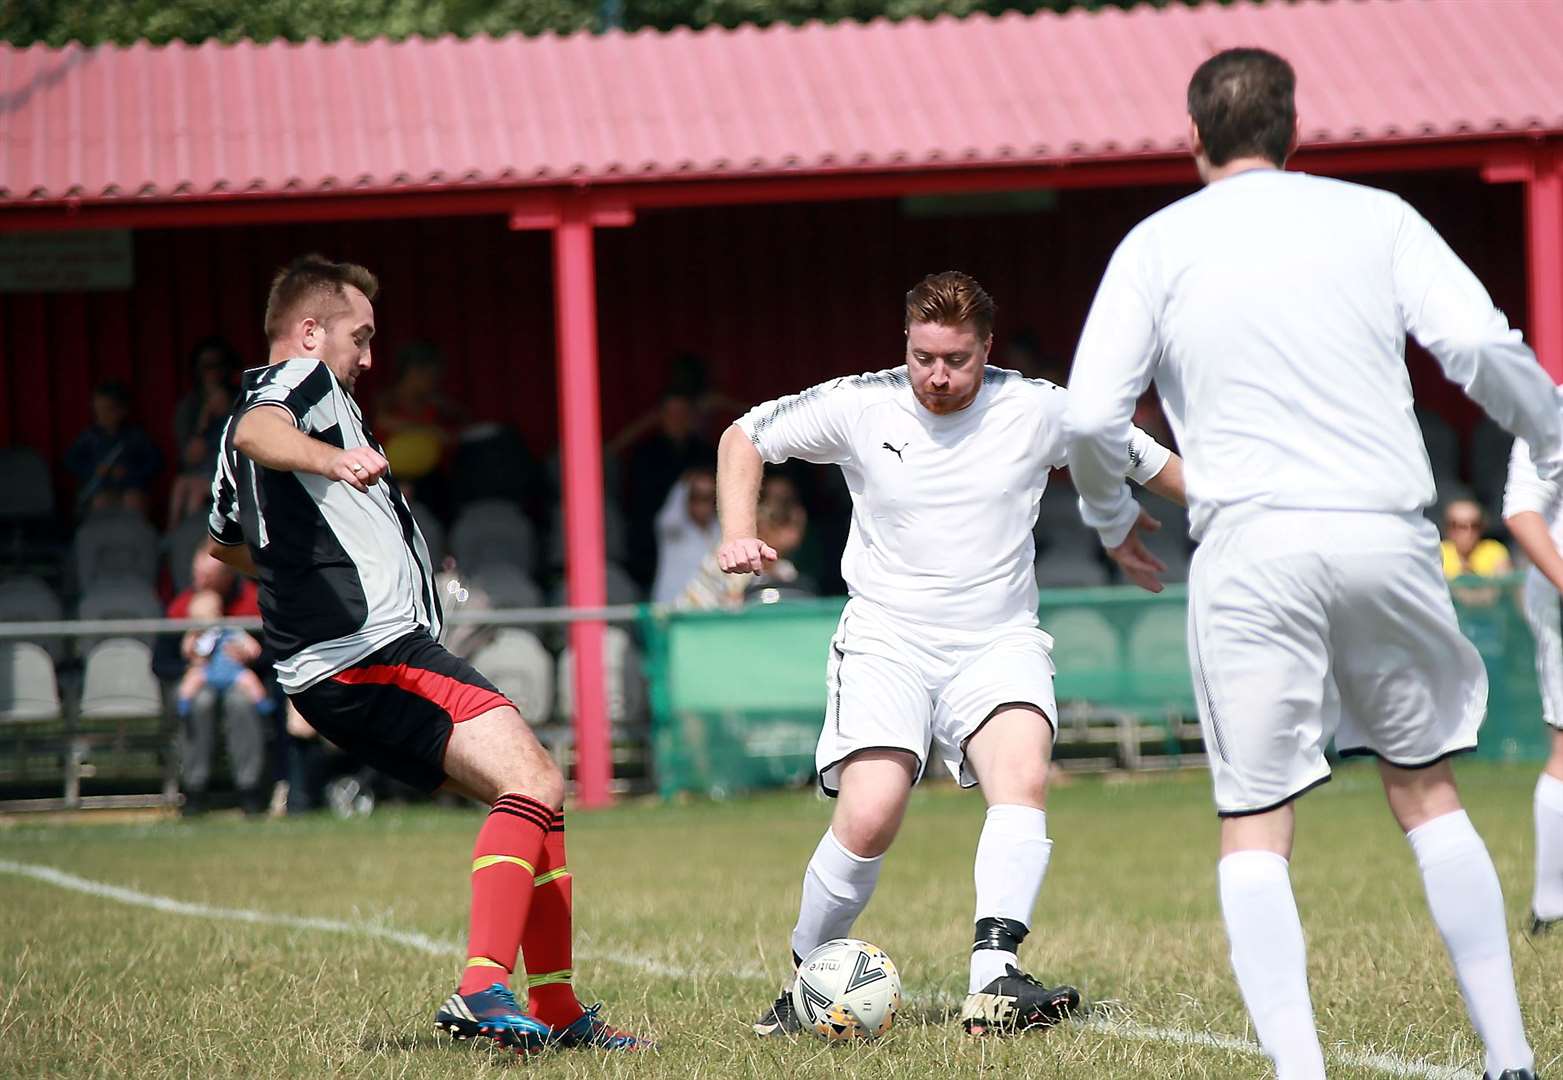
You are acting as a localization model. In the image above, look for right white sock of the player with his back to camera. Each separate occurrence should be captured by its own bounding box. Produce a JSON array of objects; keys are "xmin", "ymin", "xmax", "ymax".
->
[{"xmin": 1405, "ymin": 810, "xmax": 1535, "ymax": 1077}]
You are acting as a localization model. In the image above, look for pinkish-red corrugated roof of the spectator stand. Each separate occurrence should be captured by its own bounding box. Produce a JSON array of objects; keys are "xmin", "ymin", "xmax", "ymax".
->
[{"xmin": 0, "ymin": 0, "xmax": 1563, "ymax": 205}]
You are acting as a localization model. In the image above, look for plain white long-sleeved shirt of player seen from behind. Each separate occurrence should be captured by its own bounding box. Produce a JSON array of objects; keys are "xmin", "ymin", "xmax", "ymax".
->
[{"xmin": 1068, "ymin": 169, "xmax": 1563, "ymax": 547}]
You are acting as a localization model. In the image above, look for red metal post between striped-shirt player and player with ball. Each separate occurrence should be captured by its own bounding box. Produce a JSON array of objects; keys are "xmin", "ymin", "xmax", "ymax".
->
[{"xmin": 553, "ymin": 198, "xmax": 613, "ymax": 806}]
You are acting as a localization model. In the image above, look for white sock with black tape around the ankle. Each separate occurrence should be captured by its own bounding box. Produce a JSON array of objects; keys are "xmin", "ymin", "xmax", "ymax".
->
[{"xmin": 967, "ymin": 805, "xmax": 1053, "ymax": 994}]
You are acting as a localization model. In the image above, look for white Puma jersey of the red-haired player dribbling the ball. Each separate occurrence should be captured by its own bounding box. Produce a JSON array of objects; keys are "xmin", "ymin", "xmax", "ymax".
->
[{"xmin": 738, "ymin": 367, "xmax": 1171, "ymax": 631}]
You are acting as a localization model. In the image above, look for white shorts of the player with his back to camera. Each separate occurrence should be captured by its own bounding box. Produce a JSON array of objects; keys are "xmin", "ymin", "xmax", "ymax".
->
[{"xmin": 1188, "ymin": 511, "xmax": 1486, "ymax": 816}]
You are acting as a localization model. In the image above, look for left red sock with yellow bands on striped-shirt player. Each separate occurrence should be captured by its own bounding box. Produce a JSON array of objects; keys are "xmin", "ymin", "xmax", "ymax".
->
[{"xmin": 456, "ymin": 794, "xmax": 553, "ymax": 994}]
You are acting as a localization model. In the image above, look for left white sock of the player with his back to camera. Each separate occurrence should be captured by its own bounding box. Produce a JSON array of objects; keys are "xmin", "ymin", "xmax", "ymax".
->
[{"xmin": 1218, "ymin": 852, "xmax": 1324, "ymax": 1080}]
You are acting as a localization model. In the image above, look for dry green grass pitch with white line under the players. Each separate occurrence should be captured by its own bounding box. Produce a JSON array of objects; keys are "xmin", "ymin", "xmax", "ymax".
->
[{"xmin": 0, "ymin": 766, "xmax": 1563, "ymax": 1080}]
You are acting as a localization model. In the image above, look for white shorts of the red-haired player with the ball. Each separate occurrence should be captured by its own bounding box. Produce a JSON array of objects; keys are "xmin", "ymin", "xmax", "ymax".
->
[{"xmin": 814, "ymin": 599, "xmax": 1058, "ymax": 797}]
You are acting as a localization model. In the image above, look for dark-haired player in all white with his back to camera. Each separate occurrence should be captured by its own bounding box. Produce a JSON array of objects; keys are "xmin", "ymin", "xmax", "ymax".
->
[{"xmin": 1069, "ymin": 48, "xmax": 1563, "ymax": 1080}]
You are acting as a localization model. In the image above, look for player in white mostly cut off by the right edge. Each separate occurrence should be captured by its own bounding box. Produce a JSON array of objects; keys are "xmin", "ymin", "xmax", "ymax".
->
[{"xmin": 1504, "ymin": 418, "xmax": 1563, "ymax": 936}]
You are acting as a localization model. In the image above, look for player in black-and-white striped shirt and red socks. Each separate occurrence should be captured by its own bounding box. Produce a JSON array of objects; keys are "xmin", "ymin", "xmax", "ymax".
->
[{"xmin": 209, "ymin": 255, "xmax": 646, "ymax": 1050}]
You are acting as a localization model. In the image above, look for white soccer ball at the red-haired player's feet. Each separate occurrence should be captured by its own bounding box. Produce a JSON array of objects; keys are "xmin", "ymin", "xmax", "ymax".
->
[{"xmin": 792, "ymin": 938, "xmax": 900, "ymax": 1042}]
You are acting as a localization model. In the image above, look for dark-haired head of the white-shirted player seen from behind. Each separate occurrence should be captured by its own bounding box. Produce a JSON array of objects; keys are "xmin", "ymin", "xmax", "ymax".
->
[{"xmin": 1188, "ymin": 48, "xmax": 1297, "ymax": 166}]
